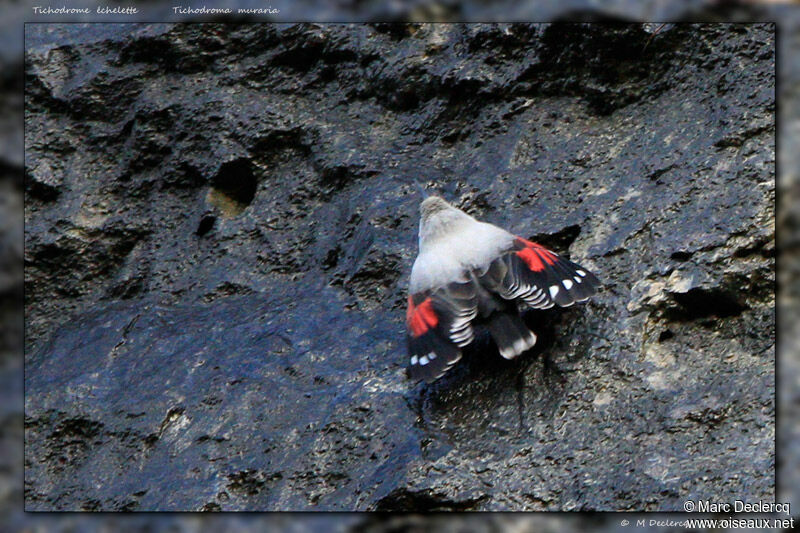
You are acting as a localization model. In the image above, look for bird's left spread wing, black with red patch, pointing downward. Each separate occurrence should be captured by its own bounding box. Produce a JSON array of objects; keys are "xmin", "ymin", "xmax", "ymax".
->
[{"xmin": 406, "ymin": 281, "xmax": 478, "ymax": 383}]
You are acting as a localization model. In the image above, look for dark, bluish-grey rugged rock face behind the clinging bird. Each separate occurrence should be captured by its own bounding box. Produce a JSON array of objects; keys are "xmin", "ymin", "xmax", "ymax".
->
[{"xmin": 25, "ymin": 24, "xmax": 775, "ymax": 511}]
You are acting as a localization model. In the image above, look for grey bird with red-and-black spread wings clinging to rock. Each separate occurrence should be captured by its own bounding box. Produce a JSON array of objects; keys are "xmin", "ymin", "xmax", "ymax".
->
[{"xmin": 406, "ymin": 195, "xmax": 600, "ymax": 383}]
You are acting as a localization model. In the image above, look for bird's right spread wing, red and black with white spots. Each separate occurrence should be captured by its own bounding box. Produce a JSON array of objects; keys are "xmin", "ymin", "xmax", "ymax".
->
[{"xmin": 481, "ymin": 237, "xmax": 600, "ymax": 309}]
